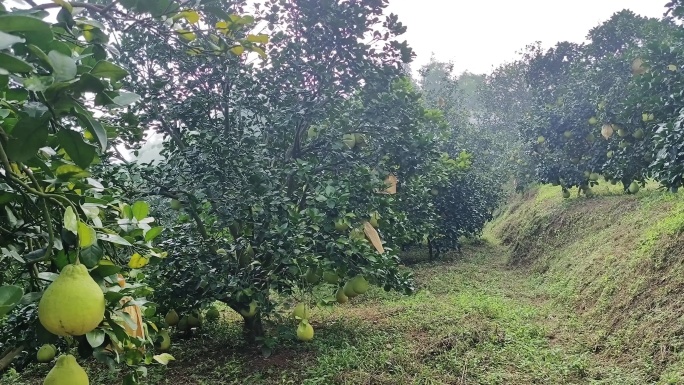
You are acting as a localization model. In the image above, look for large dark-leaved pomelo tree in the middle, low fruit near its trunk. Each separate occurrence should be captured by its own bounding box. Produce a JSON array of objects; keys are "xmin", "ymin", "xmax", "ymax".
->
[{"xmin": 104, "ymin": 1, "xmax": 440, "ymax": 341}]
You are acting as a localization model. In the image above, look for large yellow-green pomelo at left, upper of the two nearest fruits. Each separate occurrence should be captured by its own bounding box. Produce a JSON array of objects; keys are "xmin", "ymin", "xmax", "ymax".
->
[{"xmin": 38, "ymin": 264, "xmax": 105, "ymax": 336}]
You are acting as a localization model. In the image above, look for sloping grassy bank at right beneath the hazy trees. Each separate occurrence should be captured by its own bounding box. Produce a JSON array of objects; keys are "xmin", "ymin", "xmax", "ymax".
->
[{"xmin": 490, "ymin": 186, "xmax": 684, "ymax": 384}]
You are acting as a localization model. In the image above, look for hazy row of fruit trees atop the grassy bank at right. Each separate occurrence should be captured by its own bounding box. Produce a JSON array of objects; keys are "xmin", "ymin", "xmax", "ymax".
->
[{"xmin": 480, "ymin": 1, "xmax": 684, "ymax": 196}]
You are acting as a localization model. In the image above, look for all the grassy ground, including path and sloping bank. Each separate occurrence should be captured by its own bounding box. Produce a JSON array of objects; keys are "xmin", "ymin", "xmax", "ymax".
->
[{"xmin": 5, "ymin": 185, "xmax": 684, "ymax": 385}]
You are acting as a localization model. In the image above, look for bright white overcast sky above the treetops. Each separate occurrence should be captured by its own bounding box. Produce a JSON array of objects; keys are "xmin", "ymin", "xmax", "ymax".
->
[{"xmin": 389, "ymin": 0, "xmax": 667, "ymax": 74}]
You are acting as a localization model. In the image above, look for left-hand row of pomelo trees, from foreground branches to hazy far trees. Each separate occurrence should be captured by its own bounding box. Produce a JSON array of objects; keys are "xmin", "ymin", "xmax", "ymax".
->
[{"xmin": 0, "ymin": 0, "xmax": 503, "ymax": 383}]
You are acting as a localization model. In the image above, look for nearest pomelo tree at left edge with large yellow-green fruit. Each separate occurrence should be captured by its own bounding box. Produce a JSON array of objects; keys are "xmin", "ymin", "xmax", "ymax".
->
[{"xmin": 0, "ymin": 1, "xmax": 255, "ymax": 383}]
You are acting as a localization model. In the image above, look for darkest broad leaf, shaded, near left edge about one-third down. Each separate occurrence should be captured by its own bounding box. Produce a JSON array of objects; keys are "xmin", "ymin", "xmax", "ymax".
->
[{"xmin": 5, "ymin": 117, "xmax": 48, "ymax": 162}]
